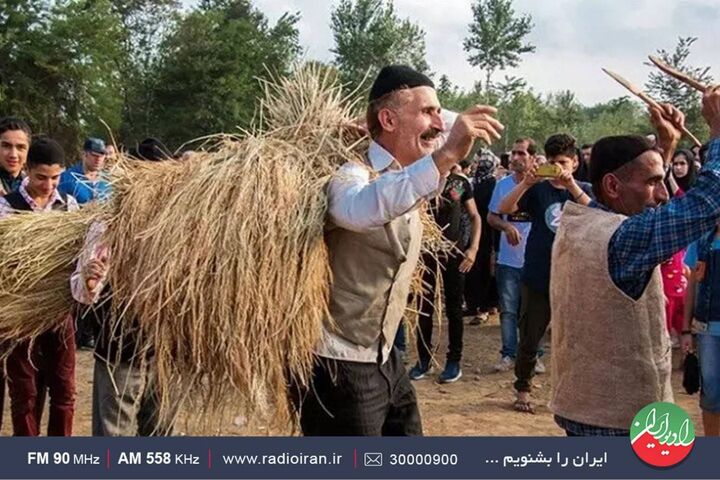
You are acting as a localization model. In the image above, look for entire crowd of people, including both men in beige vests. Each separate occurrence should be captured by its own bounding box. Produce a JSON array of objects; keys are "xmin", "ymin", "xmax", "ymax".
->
[{"xmin": 0, "ymin": 65, "xmax": 720, "ymax": 436}]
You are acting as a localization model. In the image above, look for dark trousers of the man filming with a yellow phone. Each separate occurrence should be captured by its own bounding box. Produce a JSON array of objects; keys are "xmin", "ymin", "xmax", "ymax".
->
[{"xmin": 515, "ymin": 284, "xmax": 550, "ymax": 392}]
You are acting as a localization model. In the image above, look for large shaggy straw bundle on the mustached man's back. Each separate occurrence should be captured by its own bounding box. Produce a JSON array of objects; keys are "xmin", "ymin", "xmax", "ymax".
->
[{"xmin": 101, "ymin": 64, "xmax": 450, "ymax": 429}]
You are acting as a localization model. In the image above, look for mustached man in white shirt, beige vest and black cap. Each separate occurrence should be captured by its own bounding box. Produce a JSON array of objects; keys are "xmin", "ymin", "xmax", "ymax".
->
[{"xmin": 296, "ymin": 65, "xmax": 503, "ymax": 435}]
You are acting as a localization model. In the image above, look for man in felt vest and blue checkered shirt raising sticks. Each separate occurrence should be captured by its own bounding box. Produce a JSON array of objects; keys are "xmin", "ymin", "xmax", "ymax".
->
[{"xmin": 550, "ymin": 87, "xmax": 720, "ymax": 436}]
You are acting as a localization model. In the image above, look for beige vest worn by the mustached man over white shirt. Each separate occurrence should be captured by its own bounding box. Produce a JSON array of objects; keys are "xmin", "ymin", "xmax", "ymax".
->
[{"xmin": 325, "ymin": 194, "xmax": 422, "ymax": 347}]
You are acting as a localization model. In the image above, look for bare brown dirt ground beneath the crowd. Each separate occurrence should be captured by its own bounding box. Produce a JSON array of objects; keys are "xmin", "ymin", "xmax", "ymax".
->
[{"xmin": 0, "ymin": 317, "xmax": 702, "ymax": 436}]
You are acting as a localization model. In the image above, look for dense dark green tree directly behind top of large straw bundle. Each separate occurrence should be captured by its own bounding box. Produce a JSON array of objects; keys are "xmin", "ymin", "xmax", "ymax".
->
[{"xmin": 153, "ymin": 0, "xmax": 300, "ymax": 147}]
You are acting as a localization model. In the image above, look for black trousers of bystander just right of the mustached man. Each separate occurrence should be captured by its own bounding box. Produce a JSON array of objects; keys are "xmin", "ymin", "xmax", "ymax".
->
[{"xmin": 417, "ymin": 255, "xmax": 465, "ymax": 365}]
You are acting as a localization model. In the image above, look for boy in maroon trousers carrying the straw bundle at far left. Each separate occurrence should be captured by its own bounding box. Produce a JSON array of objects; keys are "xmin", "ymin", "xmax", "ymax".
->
[{"xmin": 0, "ymin": 138, "xmax": 78, "ymax": 436}]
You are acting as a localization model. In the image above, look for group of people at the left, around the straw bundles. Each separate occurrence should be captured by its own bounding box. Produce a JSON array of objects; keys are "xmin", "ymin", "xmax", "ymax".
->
[{"xmin": 0, "ymin": 125, "xmax": 176, "ymax": 436}]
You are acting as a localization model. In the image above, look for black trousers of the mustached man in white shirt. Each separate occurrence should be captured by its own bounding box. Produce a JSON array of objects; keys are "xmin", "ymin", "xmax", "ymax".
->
[{"xmin": 292, "ymin": 348, "xmax": 422, "ymax": 436}]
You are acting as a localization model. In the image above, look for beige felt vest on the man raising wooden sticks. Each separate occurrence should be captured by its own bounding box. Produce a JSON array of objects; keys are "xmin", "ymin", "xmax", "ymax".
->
[{"xmin": 550, "ymin": 202, "xmax": 673, "ymax": 430}]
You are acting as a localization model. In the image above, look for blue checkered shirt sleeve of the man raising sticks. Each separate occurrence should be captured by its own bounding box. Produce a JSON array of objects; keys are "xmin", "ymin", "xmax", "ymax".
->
[{"xmin": 608, "ymin": 139, "xmax": 720, "ymax": 299}]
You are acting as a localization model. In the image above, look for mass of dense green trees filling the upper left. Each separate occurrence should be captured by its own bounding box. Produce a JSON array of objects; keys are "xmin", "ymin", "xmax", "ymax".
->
[{"xmin": 0, "ymin": 0, "xmax": 301, "ymax": 154}]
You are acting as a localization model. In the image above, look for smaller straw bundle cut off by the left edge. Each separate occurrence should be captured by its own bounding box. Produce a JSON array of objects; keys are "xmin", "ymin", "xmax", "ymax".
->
[{"xmin": 0, "ymin": 208, "xmax": 100, "ymax": 348}]
